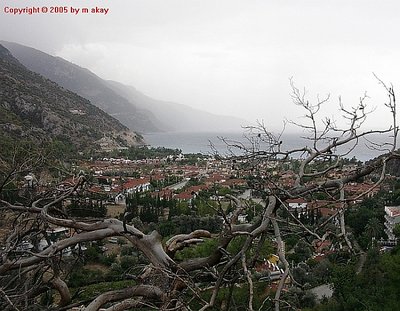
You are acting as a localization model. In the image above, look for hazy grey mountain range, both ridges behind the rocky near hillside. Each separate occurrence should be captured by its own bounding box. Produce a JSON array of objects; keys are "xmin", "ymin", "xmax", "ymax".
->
[{"xmin": 0, "ymin": 41, "xmax": 247, "ymax": 133}]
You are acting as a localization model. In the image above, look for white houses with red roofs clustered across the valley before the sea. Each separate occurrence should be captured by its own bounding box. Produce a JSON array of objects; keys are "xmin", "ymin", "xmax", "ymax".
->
[{"xmin": 19, "ymin": 154, "xmax": 394, "ymax": 299}]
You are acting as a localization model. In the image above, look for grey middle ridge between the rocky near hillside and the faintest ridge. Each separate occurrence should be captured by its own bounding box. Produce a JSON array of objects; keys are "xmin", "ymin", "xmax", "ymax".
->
[{"xmin": 0, "ymin": 41, "xmax": 163, "ymax": 132}]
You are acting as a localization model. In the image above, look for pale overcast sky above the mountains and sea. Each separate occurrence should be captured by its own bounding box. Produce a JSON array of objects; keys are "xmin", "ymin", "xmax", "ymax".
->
[{"xmin": 0, "ymin": 0, "xmax": 400, "ymax": 132}]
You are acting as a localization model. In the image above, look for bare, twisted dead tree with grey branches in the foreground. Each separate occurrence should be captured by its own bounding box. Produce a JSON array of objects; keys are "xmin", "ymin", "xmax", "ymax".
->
[{"xmin": 0, "ymin": 80, "xmax": 399, "ymax": 311}]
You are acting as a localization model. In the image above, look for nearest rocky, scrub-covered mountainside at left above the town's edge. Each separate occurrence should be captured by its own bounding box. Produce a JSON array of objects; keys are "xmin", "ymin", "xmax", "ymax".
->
[{"xmin": 0, "ymin": 45, "xmax": 143, "ymax": 156}]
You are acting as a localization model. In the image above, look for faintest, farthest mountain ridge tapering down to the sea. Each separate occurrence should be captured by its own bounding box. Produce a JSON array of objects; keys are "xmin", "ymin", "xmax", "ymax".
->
[{"xmin": 108, "ymin": 81, "xmax": 248, "ymax": 132}]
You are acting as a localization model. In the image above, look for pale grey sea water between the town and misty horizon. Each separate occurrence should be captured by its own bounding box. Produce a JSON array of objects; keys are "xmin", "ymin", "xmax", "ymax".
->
[{"xmin": 144, "ymin": 132, "xmax": 391, "ymax": 162}]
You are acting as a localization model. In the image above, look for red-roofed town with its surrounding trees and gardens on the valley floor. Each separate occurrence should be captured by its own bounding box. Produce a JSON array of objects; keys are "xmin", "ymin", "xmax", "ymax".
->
[{"xmin": 3, "ymin": 147, "xmax": 400, "ymax": 310}]
